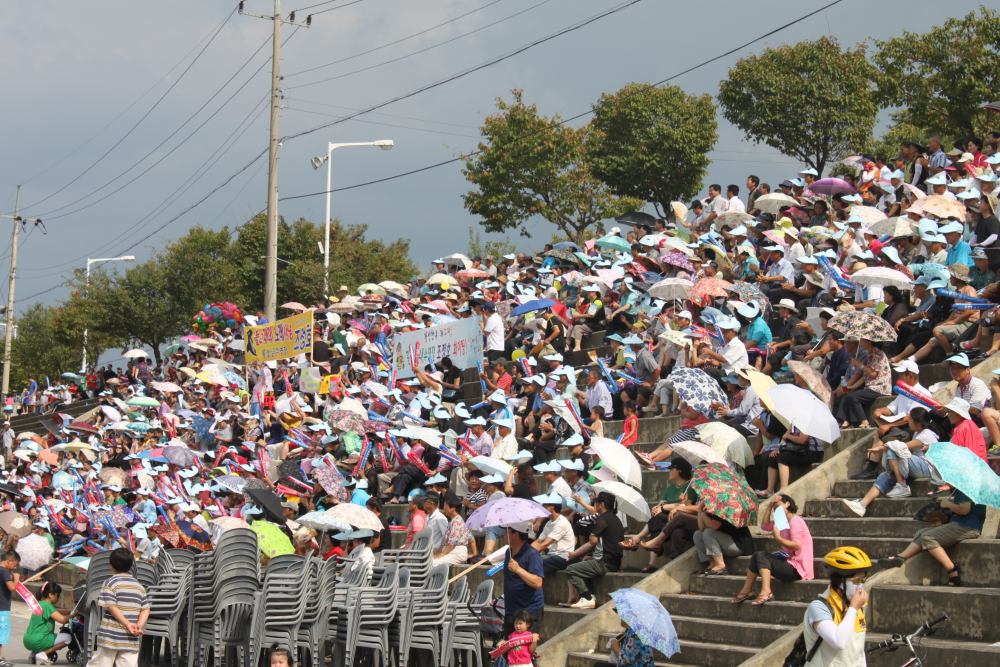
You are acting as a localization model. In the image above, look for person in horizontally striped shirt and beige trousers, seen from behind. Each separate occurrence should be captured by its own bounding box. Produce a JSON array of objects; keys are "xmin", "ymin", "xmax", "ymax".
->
[{"xmin": 87, "ymin": 549, "xmax": 149, "ymax": 667}]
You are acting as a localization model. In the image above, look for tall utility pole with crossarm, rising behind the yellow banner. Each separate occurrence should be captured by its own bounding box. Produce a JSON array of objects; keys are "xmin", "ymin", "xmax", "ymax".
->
[{"xmin": 239, "ymin": 0, "xmax": 312, "ymax": 322}]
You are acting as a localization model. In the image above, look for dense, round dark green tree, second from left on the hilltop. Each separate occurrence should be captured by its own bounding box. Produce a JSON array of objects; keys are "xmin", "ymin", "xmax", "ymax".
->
[{"xmin": 587, "ymin": 83, "xmax": 719, "ymax": 217}]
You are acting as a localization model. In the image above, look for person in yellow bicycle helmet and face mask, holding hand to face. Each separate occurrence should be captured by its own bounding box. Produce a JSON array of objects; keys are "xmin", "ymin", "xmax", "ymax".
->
[{"xmin": 803, "ymin": 547, "xmax": 872, "ymax": 667}]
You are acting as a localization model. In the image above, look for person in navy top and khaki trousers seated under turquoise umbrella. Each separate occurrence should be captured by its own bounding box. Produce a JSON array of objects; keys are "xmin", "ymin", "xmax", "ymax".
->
[{"xmin": 878, "ymin": 490, "xmax": 986, "ymax": 586}]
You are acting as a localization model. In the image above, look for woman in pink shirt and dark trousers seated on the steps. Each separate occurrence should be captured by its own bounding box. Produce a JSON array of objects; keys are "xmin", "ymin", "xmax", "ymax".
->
[{"xmin": 731, "ymin": 493, "xmax": 813, "ymax": 607}]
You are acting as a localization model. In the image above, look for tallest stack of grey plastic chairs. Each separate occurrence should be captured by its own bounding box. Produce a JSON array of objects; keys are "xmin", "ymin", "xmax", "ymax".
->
[{"xmin": 187, "ymin": 528, "xmax": 260, "ymax": 667}]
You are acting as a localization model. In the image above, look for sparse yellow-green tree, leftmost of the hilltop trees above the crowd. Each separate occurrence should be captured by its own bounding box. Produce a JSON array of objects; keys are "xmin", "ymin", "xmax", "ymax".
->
[{"xmin": 462, "ymin": 89, "xmax": 643, "ymax": 245}]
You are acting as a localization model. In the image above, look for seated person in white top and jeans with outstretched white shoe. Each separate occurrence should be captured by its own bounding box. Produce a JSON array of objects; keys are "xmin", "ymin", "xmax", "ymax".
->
[{"xmin": 844, "ymin": 408, "xmax": 940, "ymax": 516}]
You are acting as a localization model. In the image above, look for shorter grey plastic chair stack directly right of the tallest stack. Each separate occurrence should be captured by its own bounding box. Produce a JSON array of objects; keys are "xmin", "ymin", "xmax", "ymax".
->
[{"xmin": 247, "ymin": 556, "xmax": 322, "ymax": 665}]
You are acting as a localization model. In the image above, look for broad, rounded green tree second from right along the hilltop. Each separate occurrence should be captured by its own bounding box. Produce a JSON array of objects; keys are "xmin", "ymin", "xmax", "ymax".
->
[{"xmin": 719, "ymin": 37, "xmax": 878, "ymax": 175}]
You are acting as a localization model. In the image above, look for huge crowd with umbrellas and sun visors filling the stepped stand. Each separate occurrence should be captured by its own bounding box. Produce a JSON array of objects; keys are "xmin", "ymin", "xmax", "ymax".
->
[{"xmin": 0, "ymin": 140, "xmax": 1000, "ymax": 664}]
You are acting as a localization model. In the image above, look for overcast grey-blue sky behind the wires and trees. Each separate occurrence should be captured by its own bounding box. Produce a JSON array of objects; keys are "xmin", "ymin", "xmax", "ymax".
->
[{"xmin": 0, "ymin": 0, "xmax": 980, "ymax": 311}]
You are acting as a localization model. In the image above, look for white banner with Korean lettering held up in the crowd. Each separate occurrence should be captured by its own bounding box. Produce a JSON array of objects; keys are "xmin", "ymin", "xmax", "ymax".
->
[{"xmin": 392, "ymin": 318, "xmax": 483, "ymax": 378}]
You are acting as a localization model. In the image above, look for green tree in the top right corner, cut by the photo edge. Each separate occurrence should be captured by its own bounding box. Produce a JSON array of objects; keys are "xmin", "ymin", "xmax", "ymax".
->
[{"xmin": 872, "ymin": 7, "xmax": 1000, "ymax": 137}]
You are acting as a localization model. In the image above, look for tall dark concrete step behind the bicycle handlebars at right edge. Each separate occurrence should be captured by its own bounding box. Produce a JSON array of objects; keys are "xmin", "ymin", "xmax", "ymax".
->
[{"xmin": 868, "ymin": 586, "xmax": 1000, "ymax": 644}]
